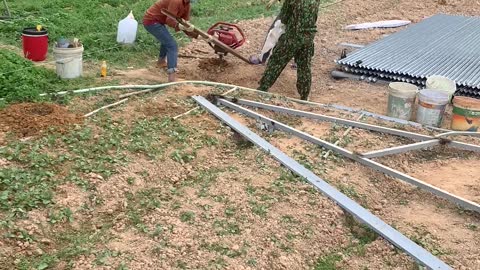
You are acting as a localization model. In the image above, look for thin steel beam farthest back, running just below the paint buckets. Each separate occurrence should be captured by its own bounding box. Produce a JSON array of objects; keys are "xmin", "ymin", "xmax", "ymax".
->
[{"xmin": 226, "ymin": 98, "xmax": 480, "ymax": 152}]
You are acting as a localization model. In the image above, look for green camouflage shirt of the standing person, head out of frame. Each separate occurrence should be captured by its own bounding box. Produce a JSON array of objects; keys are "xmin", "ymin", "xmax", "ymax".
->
[{"xmin": 279, "ymin": 0, "xmax": 321, "ymax": 34}]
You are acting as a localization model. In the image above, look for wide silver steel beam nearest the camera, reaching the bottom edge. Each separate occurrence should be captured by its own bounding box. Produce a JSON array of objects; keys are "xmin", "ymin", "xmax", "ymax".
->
[{"xmin": 193, "ymin": 96, "xmax": 451, "ymax": 269}]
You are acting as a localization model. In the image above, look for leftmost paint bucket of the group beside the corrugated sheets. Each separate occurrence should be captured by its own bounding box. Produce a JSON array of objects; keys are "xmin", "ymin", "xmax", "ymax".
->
[{"xmin": 387, "ymin": 82, "xmax": 418, "ymax": 120}]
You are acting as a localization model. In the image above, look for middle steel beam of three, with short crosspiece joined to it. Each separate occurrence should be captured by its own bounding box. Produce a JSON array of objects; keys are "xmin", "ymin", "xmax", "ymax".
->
[{"xmin": 218, "ymin": 99, "xmax": 480, "ymax": 213}]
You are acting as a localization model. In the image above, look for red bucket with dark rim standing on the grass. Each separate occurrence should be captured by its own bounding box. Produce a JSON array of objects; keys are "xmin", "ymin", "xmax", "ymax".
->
[{"xmin": 22, "ymin": 28, "xmax": 48, "ymax": 62}]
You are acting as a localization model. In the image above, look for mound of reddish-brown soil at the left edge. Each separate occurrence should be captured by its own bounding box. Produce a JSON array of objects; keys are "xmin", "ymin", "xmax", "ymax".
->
[{"xmin": 0, "ymin": 103, "xmax": 83, "ymax": 137}]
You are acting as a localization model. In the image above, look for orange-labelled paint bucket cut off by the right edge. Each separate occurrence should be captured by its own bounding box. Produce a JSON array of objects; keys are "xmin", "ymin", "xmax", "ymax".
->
[{"xmin": 452, "ymin": 97, "xmax": 480, "ymax": 132}]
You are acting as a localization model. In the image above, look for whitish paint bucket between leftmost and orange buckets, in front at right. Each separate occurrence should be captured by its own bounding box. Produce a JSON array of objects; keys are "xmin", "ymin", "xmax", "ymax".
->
[{"xmin": 417, "ymin": 89, "xmax": 450, "ymax": 127}]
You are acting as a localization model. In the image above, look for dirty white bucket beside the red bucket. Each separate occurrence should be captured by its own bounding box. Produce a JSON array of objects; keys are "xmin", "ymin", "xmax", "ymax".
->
[{"xmin": 53, "ymin": 46, "xmax": 83, "ymax": 79}]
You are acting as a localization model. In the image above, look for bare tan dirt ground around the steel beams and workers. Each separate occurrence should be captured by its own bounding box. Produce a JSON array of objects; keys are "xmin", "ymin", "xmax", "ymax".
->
[{"xmin": 0, "ymin": 0, "xmax": 480, "ymax": 269}]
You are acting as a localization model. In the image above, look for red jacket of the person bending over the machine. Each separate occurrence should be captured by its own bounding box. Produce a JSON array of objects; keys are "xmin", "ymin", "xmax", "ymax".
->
[{"xmin": 143, "ymin": 0, "xmax": 190, "ymax": 31}]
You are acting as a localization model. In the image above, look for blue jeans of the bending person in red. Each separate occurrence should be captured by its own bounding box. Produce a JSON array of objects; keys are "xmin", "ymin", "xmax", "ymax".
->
[{"xmin": 144, "ymin": 23, "xmax": 178, "ymax": 73}]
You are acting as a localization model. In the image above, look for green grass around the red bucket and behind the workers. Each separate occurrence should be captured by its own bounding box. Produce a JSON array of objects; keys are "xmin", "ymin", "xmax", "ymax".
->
[{"xmin": 0, "ymin": 0, "xmax": 276, "ymax": 103}]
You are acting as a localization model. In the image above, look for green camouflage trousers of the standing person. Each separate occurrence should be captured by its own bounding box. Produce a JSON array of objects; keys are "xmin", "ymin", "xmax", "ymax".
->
[{"xmin": 258, "ymin": 34, "xmax": 315, "ymax": 100}]
